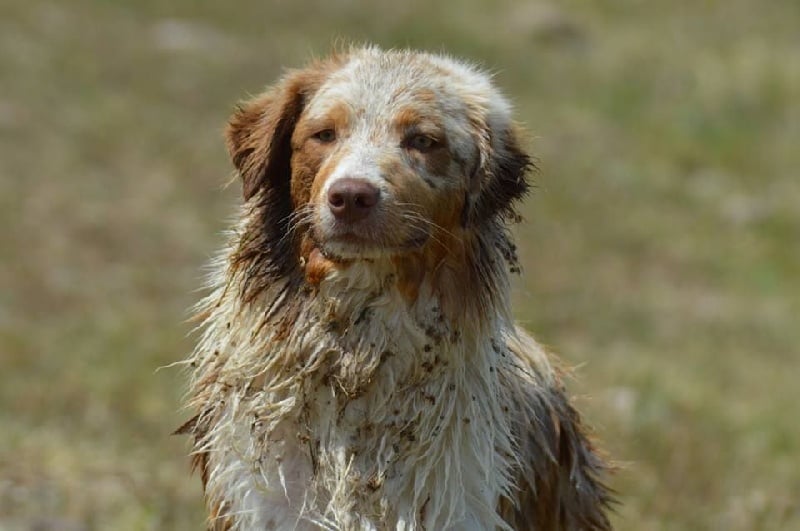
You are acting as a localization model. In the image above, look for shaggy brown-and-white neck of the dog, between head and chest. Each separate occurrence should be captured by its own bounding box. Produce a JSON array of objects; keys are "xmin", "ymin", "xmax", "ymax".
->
[{"xmin": 195, "ymin": 222, "xmax": 516, "ymax": 408}]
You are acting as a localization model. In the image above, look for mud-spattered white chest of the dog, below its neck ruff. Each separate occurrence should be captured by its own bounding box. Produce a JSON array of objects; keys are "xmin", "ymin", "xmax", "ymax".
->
[{"xmin": 219, "ymin": 282, "xmax": 505, "ymax": 529}]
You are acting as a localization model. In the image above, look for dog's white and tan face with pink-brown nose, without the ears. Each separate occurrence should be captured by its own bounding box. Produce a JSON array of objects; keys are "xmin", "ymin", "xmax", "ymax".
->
[{"xmin": 291, "ymin": 64, "xmax": 472, "ymax": 259}]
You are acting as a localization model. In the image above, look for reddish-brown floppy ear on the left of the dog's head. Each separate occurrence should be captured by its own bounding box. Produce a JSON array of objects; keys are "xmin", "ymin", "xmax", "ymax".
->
[{"xmin": 225, "ymin": 63, "xmax": 330, "ymax": 201}]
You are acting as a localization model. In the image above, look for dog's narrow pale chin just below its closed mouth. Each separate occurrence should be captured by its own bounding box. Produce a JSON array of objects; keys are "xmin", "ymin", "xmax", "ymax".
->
[{"xmin": 317, "ymin": 233, "xmax": 429, "ymax": 262}]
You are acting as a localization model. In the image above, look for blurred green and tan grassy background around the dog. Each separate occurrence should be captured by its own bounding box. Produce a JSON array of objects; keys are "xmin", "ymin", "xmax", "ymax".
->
[{"xmin": 0, "ymin": 0, "xmax": 800, "ymax": 531}]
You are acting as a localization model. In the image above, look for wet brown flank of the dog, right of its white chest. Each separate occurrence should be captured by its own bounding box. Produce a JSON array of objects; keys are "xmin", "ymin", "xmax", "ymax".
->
[{"xmin": 498, "ymin": 328, "xmax": 614, "ymax": 530}]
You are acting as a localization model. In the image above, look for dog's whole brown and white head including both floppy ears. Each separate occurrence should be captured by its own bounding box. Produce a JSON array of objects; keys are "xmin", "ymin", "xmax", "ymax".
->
[{"xmin": 226, "ymin": 48, "xmax": 530, "ymax": 290}]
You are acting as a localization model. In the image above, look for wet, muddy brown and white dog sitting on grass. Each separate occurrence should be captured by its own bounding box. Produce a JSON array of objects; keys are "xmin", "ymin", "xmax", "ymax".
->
[{"xmin": 179, "ymin": 47, "xmax": 612, "ymax": 531}]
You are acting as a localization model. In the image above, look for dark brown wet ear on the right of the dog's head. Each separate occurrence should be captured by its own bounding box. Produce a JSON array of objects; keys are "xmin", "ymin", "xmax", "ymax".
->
[{"xmin": 462, "ymin": 115, "xmax": 534, "ymax": 225}]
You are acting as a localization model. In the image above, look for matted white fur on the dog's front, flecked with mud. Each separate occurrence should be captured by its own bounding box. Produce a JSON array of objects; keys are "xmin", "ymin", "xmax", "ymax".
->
[{"xmin": 190, "ymin": 240, "xmax": 540, "ymax": 530}]
